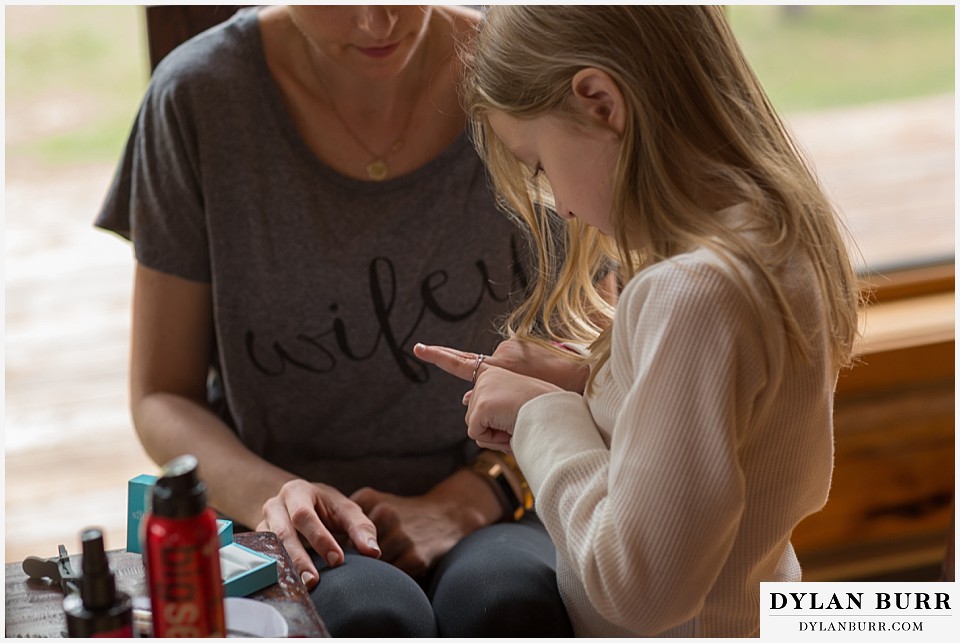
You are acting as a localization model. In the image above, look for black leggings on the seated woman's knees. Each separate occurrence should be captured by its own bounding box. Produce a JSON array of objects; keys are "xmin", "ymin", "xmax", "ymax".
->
[{"xmin": 311, "ymin": 514, "xmax": 573, "ymax": 637}]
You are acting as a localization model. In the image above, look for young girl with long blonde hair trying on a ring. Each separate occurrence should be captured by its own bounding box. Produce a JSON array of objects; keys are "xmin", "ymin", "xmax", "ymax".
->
[{"xmin": 416, "ymin": 5, "xmax": 859, "ymax": 637}]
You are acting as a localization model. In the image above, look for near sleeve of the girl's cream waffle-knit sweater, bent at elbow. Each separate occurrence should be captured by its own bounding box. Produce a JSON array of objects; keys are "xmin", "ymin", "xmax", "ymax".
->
[{"xmin": 513, "ymin": 256, "xmax": 764, "ymax": 635}]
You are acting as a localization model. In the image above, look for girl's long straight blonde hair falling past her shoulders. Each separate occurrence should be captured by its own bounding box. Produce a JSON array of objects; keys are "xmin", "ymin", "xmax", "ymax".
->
[{"xmin": 464, "ymin": 5, "xmax": 860, "ymax": 381}]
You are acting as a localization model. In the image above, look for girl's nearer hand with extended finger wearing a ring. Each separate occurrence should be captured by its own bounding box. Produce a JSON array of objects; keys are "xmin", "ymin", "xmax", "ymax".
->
[{"xmin": 413, "ymin": 344, "xmax": 564, "ymax": 453}]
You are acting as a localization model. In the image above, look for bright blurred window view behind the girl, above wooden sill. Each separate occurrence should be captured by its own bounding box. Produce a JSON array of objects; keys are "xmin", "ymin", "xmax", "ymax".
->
[{"xmin": 727, "ymin": 5, "xmax": 954, "ymax": 287}]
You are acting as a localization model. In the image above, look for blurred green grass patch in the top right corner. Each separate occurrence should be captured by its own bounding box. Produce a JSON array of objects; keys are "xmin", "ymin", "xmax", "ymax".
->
[{"xmin": 728, "ymin": 5, "xmax": 954, "ymax": 112}]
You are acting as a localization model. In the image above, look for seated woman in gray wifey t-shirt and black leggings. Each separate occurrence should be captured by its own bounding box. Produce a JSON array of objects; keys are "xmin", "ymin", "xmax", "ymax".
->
[{"xmin": 97, "ymin": 6, "xmax": 570, "ymax": 636}]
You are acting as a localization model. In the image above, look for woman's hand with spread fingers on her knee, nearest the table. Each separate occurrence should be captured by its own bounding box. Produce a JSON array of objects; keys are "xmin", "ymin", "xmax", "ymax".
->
[{"xmin": 257, "ymin": 479, "xmax": 380, "ymax": 589}]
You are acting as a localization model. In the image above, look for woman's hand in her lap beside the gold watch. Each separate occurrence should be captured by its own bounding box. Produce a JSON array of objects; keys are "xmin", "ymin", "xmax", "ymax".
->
[{"xmin": 350, "ymin": 471, "xmax": 501, "ymax": 577}]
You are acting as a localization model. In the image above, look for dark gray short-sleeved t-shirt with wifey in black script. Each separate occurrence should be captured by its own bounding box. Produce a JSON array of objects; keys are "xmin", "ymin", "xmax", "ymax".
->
[{"xmin": 96, "ymin": 10, "xmax": 523, "ymax": 494}]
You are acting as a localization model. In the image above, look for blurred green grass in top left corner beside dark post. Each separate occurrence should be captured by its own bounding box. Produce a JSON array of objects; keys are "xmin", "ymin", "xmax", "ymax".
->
[{"xmin": 4, "ymin": 5, "xmax": 149, "ymax": 167}]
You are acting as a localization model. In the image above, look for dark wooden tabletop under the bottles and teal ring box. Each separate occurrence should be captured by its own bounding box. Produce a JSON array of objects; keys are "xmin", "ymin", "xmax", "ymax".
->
[{"xmin": 5, "ymin": 532, "xmax": 329, "ymax": 638}]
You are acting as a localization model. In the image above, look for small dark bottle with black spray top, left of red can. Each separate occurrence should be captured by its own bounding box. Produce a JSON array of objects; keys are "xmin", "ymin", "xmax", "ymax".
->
[{"xmin": 63, "ymin": 528, "xmax": 133, "ymax": 638}]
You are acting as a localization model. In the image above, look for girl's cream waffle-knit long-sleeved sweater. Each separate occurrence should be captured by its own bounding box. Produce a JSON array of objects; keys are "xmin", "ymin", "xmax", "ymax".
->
[{"xmin": 512, "ymin": 249, "xmax": 836, "ymax": 637}]
